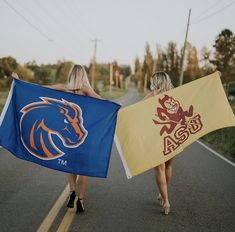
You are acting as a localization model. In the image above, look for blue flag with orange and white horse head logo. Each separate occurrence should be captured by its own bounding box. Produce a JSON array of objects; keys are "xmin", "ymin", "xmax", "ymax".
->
[{"xmin": 0, "ymin": 80, "xmax": 120, "ymax": 177}]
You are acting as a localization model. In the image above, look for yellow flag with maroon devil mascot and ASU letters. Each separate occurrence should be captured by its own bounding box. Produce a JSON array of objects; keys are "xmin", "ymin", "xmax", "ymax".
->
[{"xmin": 115, "ymin": 72, "xmax": 235, "ymax": 178}]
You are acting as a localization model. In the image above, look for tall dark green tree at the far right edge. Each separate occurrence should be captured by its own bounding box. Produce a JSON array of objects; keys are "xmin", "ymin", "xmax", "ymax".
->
[{"xmin": 211, "ymin": 29, "xmax": 235, "ymax": 88}]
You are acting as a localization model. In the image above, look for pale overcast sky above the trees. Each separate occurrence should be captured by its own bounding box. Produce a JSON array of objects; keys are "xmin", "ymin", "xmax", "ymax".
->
[{"xmin": 0, "ymin": 0, "xmax": 235, "ymax": 65}]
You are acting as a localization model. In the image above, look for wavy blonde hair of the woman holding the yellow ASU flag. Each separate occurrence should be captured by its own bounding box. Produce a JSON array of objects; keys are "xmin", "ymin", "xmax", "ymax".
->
[{"xmin": 150, "ymin": 71, "xmax": 174, "ymax": 94}]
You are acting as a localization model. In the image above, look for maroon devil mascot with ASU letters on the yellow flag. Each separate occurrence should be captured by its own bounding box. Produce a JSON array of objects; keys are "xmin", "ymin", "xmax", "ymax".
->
[{"xmin": 153, "ymin": 95, "xmax": 203, "ymax": 155}]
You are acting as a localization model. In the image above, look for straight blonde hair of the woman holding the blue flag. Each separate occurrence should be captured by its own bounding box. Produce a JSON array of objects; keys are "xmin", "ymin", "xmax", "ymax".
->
[{"xmin": 67, "ymin": 64, "xmax": 91, "ymax": 90}]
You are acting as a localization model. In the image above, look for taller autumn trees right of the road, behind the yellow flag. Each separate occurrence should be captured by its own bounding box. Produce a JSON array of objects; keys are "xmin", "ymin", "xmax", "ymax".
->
[{"xmin": 134, "ymin": 29, "xmax": 235, "ymax": 94}]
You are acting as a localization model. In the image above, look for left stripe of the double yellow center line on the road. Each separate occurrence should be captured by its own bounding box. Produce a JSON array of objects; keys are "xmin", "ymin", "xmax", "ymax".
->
[{"xmin": 37, "ymin": 185, "xmax": 70, "ymax": 232}]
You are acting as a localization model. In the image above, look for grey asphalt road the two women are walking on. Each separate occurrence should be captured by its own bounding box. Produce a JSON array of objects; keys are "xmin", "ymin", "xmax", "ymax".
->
[{"xmin": 0, "ymin": 86, "xmax": 235, "ymax": 232}]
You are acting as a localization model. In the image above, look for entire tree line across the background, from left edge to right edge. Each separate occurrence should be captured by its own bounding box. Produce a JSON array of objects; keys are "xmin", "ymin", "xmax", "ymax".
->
[{"xmin": 0, "ymin": 29, "xmax": 235, "ymax": 94}]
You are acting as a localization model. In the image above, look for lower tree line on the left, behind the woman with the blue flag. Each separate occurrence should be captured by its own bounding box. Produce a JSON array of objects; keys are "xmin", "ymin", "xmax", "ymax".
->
[{"xmin": 0, "ymin": 56, "xmax": 131, "ymax": 91}]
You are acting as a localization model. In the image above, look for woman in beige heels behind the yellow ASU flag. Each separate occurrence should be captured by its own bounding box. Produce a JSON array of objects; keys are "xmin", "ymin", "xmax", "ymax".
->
[{"xmin": 144, "ymin": 71, "xmax": 174, "ymax": 215}]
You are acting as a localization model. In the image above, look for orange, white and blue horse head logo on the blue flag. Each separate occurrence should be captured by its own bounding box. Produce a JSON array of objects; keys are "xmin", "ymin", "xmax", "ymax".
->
[{"xmin": 20, "ymin": 97, "xmax": 88, "ymax": 160}]
